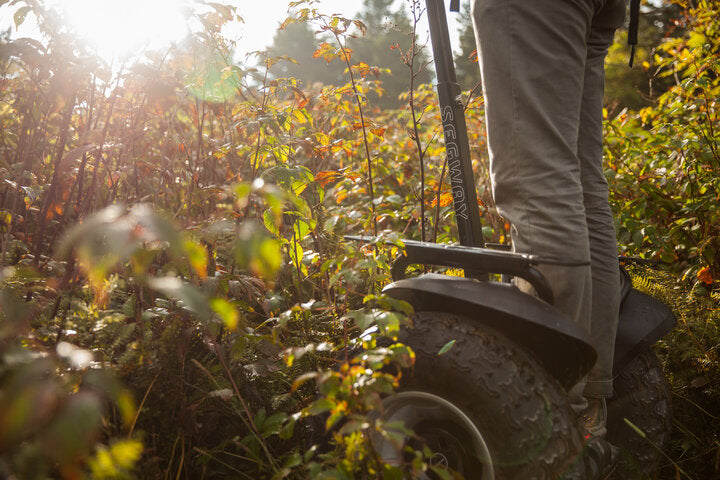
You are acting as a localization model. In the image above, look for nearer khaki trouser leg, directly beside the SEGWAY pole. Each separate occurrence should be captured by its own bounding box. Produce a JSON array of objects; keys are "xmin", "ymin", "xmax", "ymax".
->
[{"xmin": 473, "ymin": 0, "xmax": 595, "ymax": 332}]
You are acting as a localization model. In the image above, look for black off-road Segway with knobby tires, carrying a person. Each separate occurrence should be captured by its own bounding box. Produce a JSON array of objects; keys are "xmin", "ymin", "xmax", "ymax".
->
[{"xmin": 349, "ymin": 0, "xmax": 676, "ymax": 480}]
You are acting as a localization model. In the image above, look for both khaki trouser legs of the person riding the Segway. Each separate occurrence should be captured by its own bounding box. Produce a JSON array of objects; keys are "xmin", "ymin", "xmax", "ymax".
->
[{"xmin": 473, "ymin": 0, "xmax": 624, "ymax": 402}]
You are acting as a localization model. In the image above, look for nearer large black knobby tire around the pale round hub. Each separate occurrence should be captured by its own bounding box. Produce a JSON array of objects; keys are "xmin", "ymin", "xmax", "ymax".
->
[{"xmin": 380, "ymin": 312, "xmax": 584, "ymax": 480}]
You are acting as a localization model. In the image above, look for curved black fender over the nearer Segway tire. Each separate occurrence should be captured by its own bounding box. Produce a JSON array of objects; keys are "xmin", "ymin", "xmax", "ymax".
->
[{"xmin": 383, "ymin": 274, "xmax": 597, "ymax": 388}]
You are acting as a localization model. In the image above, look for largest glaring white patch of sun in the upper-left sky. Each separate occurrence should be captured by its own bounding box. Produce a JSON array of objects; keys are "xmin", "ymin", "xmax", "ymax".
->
[{"xmin": 59, "ymin": 0, "xmax": 188, "ymax": 59}]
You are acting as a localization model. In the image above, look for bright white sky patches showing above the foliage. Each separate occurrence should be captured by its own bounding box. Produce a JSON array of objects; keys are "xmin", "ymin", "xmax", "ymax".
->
[{"xmin": 0, "ymin": 0, "xmax": 457, "ymax": 60}]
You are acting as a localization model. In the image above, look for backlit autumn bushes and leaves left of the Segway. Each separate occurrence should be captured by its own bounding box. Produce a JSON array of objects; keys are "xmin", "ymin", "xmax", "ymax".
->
[{"xmin": 0, "ymin": 2, "xmax": 450, "ymax": 479}]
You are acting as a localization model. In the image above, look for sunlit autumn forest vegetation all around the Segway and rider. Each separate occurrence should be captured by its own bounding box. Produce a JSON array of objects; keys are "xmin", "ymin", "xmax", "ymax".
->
[{"xmin": 0, "ymin": 0, "xmax": 720, "ymax": 479}]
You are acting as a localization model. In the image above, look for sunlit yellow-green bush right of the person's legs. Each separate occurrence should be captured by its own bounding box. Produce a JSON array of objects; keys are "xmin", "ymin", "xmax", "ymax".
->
[{"xmin": 606, "ymin": 0, "xmax": 720, "ymax": 288}]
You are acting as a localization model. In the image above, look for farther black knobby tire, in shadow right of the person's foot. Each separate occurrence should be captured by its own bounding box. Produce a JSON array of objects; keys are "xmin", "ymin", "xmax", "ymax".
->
[{"xmin": 607, "ymin": 348, "xmax": 672, "ymax": 480}]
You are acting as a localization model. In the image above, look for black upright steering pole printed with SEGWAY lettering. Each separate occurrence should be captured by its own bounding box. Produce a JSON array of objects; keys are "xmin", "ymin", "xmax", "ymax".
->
[{"xmin": 426, "ymin": 0, "xmax": 485, "ymax": 247}]
